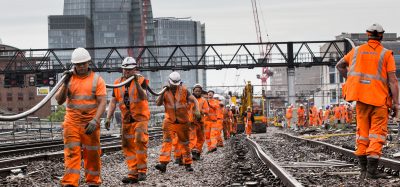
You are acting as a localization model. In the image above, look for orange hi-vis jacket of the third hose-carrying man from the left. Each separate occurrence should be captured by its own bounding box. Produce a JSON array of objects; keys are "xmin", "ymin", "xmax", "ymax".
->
[{"xmin": 164, "ymin": 85, "xmax": 189, "ymax": 124}]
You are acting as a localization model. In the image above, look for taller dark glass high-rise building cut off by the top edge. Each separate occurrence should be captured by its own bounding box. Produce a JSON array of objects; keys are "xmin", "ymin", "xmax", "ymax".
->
[{"xmin": 48, "ymin": 0, "xmax": 154, "ymax": 95}]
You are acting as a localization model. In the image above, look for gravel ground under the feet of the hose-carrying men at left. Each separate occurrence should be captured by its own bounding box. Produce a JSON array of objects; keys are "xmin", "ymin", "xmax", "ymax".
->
[{"xmin": 0, "ymin": 137, "xmax": 234, "ymax": 186}]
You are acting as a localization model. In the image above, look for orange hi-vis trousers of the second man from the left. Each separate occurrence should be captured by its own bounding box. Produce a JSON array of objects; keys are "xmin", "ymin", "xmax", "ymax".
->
[{"xmin": 122, "ymin": 121, "xmax": 149, "ymax": 178}]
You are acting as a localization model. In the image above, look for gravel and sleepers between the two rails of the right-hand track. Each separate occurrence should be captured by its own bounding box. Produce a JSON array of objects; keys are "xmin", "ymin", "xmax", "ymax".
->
[{"xmin": 255, "ymin": 128, "xmax": 400, "ymax": 186}]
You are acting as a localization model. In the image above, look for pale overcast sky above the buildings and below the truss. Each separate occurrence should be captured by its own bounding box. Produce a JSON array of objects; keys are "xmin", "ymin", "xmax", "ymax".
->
[{"xmin": 0, "ymin": 0, "xmax": 400, "ymax": 90}]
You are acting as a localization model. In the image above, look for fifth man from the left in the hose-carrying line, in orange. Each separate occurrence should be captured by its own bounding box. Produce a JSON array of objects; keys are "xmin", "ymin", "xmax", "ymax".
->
[{"xmin": 204, "ymin": 90, "xmax": 219, "ymax": 153}]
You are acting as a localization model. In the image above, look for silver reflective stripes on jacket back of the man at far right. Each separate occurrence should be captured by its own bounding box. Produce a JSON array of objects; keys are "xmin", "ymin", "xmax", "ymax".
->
[{"xmin": 347, "ymin": 47, "xmax": 388, "ymax": 84}]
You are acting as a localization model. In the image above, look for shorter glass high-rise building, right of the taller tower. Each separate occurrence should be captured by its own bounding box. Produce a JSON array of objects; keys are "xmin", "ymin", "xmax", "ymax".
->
[{"xmin": 150, "ymin": 18, "xmax": 207, "ymax": 88}]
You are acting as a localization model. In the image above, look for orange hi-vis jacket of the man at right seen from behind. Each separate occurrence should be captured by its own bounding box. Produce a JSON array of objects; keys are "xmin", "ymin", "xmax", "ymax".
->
[{"xmin": 343, "ymin": 40, "xmax": 396, "ymax": 106}]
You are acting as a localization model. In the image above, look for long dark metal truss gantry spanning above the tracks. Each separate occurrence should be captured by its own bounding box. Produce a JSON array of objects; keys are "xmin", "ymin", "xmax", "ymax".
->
[{"xmin": 0, "ymin": 40, "xmax": 351, "ymax": 75}]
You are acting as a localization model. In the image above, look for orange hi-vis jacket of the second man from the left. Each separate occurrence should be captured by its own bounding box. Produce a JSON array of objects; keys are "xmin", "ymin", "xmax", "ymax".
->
[{"xmin": 114, "ymin": 76, "xmax": 150, "ymax": 121}]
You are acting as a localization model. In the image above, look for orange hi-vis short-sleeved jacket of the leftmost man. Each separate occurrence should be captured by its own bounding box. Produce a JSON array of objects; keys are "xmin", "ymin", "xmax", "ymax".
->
[{"xmin": 65, "ymin": 71, "xmax": 106, "ymax": 125}]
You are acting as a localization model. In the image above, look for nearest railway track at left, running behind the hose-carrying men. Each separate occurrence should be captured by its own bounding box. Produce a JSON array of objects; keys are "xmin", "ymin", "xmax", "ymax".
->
[{"xmin": 0, "ymin": 129, "xmax": 162, "ymax": 176}]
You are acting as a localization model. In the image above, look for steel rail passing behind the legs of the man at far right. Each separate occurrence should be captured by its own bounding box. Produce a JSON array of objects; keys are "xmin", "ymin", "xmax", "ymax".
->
[{"xmin": 279, "ymin": 133, "xmax": 400, "ymax": 172}]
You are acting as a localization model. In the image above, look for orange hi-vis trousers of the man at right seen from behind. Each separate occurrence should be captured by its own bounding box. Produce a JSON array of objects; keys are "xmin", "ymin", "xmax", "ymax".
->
[{"xmin": 354, "ymin": 101, "xmax": 389, "ymax": 158}]
